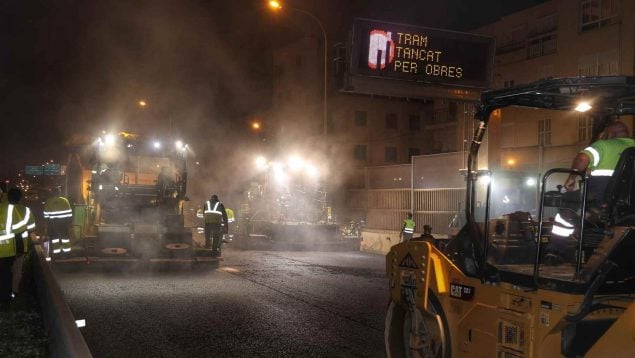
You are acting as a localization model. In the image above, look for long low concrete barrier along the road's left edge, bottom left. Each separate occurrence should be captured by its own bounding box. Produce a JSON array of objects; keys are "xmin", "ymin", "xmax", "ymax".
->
[{"xmin": 33, "ymin": 245, "xmax": 92, "ymax": 358}]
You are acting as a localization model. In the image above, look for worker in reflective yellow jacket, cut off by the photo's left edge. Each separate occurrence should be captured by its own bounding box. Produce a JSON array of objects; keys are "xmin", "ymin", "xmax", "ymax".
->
[{"xmin": 0, "ymin": 187, "xmax": 24, "ymax": 311}]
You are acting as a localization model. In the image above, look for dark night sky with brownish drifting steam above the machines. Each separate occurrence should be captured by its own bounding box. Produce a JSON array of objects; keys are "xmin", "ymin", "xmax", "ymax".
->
[{"xmin": 0, "ymin": 0, "xmax": 542, "ymax": 177}]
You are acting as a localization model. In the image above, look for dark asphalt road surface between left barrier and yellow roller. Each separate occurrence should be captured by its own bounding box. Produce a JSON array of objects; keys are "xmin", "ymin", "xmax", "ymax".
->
[{"xmin": 56, "ymin": 249, "xmax": 388, "ymax": 357}]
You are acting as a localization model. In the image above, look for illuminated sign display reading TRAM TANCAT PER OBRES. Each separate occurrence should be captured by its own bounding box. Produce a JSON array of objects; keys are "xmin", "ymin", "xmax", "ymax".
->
[{"xmin": 351, "ymin": 19, "xmax": 494, "ymax": 88}]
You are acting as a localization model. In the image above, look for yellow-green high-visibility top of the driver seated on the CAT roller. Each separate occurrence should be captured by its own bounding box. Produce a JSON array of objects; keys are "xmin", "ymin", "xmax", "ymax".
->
[{"xmin": 581, "ymin": 138, "xmax": 635, "ymax": 177}]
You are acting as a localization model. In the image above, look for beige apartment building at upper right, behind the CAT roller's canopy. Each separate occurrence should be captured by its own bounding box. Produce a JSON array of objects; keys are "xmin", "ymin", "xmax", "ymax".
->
[{"xmin": 474, "ymin": 0, "xmax": 635, "ymax": 173}]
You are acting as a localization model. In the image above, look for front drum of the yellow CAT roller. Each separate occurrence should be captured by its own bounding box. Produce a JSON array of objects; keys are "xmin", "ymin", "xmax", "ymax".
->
[{"xmin": 384, "ymin": 292, "xmax": 451, "ymax": 358}]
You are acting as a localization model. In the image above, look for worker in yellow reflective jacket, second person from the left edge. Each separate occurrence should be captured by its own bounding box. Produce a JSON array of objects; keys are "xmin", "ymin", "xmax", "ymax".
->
[{"xmin": 7, "ymin": 188, "xmax": 35, "ymax": 296}]
